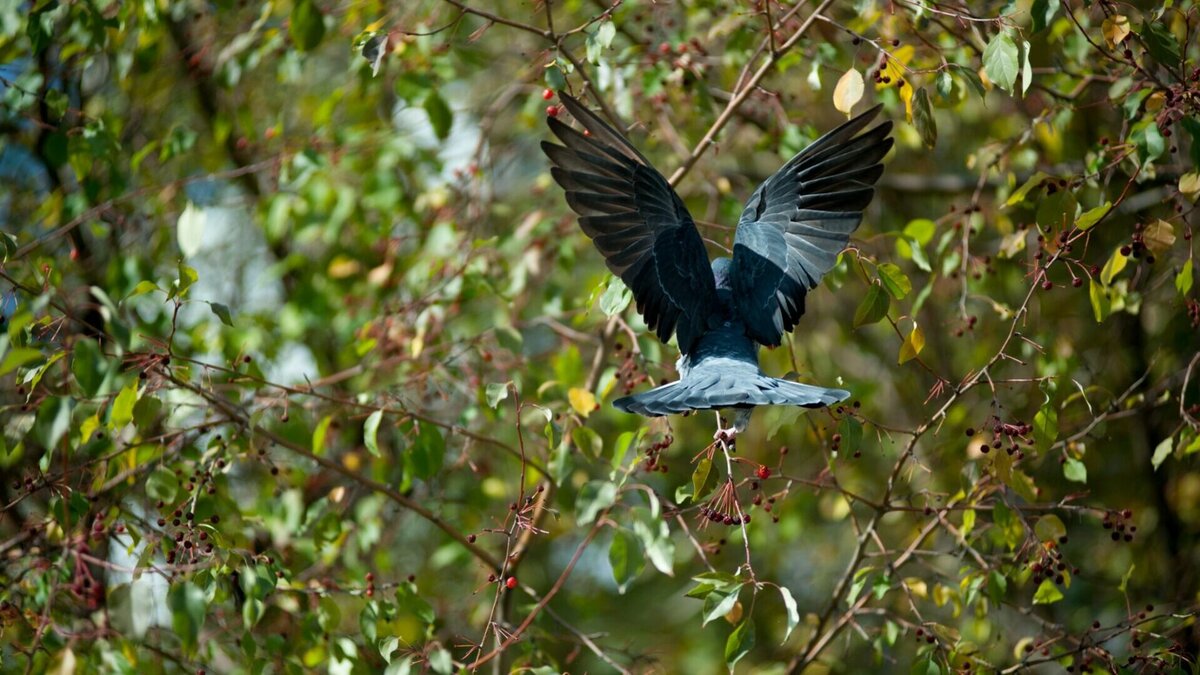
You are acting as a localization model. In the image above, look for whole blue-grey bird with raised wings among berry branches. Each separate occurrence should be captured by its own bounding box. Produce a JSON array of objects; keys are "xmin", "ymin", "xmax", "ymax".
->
[{"xmin": 541, "ymin": 92, "xmax": 892, "ymax": 444}]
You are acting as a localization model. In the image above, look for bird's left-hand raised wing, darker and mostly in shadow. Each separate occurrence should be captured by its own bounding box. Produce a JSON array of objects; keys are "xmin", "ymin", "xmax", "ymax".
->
[{"xmin": 541, "ymin": 94, "xmax": 718, "ymax": 354}]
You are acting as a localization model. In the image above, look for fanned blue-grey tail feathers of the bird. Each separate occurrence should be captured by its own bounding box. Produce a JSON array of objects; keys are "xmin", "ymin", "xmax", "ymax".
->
[{"xmin": 613, "ymin": 372, "xmax": 850, "ymax": 417}]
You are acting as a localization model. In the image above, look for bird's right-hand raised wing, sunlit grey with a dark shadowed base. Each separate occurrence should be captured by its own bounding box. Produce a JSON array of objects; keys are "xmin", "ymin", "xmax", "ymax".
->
[{"xmin": 730, "ymin": 106, "xmax": 892, "ymax": 346}]
